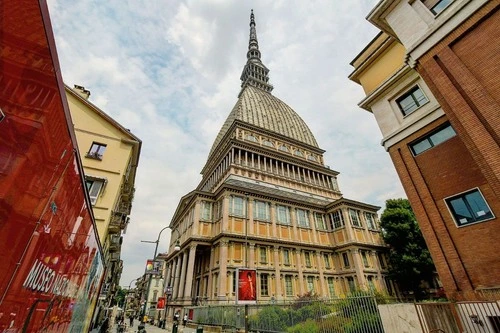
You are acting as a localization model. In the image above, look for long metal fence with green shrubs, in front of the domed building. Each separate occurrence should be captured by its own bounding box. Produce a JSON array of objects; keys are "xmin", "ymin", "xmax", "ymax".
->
[{"xmin": 189, "ymin": 295, "xmax": 384, "ymax": 333}]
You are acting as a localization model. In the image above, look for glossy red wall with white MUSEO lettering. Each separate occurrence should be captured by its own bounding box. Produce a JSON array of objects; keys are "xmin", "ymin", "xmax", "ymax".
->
[{"xmin": 0, "ymin": 0, "xmax": 103, "ymax": 332}]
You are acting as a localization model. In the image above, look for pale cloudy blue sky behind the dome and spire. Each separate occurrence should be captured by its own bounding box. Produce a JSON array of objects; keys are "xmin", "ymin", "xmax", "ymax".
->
[{"xmin": 48, "ymin": 0, "xmax": 405, "ymax": 286}]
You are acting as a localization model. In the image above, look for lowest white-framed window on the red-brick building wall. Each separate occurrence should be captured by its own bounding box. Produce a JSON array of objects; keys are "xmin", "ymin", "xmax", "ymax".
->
[{"xmin": 445, "ymin": 189, "xmax": 493, "ymax": 227}]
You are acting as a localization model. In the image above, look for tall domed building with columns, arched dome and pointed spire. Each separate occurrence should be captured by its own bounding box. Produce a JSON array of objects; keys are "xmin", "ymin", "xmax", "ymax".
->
[{"xmin": 165, "ymin": 12, "xmax": 391, "ymax": 315}]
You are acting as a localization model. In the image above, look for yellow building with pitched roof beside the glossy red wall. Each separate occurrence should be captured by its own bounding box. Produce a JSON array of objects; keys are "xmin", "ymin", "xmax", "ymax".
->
[{"xmin": 65, "ymin": 85, "xmax": 142, "ymax": 314}]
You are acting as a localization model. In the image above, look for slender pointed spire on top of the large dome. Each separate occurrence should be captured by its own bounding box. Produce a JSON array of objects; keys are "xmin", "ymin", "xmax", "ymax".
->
[{"xmin": 240, "ymin": 9, "xmax": 273, "ymax": 94}]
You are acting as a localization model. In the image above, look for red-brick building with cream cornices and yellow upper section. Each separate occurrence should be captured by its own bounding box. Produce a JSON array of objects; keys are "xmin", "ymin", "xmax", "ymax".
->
[{"xmin": 350, "ymin": 0, "xmax": 500, "ymax": 299}]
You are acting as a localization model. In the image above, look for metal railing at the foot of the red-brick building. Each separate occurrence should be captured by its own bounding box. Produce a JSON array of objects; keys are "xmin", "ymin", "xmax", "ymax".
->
[{"xmin": 415, "ymin": 302, "xmax": 500, "ymax": 333}]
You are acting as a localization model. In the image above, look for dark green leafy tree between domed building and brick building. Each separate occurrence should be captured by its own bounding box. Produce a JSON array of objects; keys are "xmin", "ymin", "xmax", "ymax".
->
[{"xmin": 380, "ymin": 199, "xmax": 435, "ymax": 299}]
